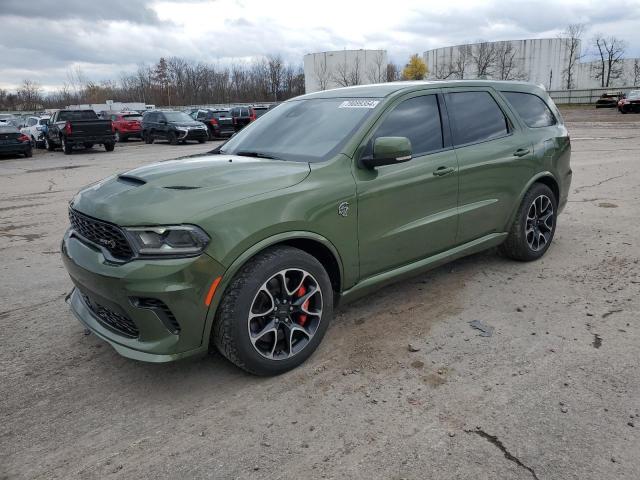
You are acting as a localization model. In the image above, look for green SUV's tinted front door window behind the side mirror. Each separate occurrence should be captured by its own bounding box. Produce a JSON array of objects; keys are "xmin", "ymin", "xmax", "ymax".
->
[{"xmin": 368, "ymin": 95, "xmax": 443, "ymax": 156}]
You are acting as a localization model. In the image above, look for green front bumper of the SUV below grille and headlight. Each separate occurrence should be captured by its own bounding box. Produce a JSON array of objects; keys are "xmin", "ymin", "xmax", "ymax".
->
[{"xmin": 62, "ymin": 231, "xmax": 224, "ymax": 362}]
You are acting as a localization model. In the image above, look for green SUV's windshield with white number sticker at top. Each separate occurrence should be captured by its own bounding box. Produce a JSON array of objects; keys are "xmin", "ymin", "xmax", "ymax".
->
[{"xmin": 220, "ymin": 98, "xmax": 379, "ymax": 162}]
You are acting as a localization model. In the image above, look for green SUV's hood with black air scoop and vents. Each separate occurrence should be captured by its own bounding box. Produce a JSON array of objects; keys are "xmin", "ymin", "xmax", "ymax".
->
[{"xmin": 72, "ymin": 155, "xmax": 310, "ymax": 226}]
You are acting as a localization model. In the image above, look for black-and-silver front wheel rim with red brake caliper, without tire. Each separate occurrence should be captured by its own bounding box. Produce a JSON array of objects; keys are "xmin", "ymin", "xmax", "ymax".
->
[{"xmin": 247, "ymin": 268, "xmax": 322, "ymax": 360}]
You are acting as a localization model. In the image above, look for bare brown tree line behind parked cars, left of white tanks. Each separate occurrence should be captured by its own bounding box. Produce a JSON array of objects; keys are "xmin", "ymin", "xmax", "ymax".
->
[{"xmin": 0, "ymin": 55, "xmax": 304, "ymax": 111}]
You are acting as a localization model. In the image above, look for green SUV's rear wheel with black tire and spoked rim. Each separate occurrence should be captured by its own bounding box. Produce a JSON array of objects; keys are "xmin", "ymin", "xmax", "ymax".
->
[{"xmin": 500, "ymin": 183, "xmax": 558, "ymax": 262}]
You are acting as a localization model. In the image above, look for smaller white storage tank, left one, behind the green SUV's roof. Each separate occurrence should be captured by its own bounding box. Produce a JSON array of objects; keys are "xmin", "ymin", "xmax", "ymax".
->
[{"xmin": 304, "ymin": 50, "xmax": 388, "ymax": 93}]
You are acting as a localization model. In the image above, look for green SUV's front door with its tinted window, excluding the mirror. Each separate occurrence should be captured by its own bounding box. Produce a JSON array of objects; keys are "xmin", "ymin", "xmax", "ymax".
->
[{"xmin": 354, "ymin": 90, "xmax": 458, "ymax": 278}]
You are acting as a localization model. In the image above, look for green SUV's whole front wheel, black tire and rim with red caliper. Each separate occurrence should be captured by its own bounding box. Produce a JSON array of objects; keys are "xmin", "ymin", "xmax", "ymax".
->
[{"xmin": 211, "ymin": 246, "xmax": 333, "ymax": 375}]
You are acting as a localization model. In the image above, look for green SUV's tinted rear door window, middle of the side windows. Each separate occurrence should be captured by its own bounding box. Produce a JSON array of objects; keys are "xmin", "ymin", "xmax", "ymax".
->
[{"xmin": 445, "ymin": 92, "xmax": 509, "ymax": 145}]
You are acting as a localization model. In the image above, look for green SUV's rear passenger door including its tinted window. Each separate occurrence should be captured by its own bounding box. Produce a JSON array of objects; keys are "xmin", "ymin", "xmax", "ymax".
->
[{"xmin": 444, "ymin": 87, "xmax": 534, "ymax": 244}]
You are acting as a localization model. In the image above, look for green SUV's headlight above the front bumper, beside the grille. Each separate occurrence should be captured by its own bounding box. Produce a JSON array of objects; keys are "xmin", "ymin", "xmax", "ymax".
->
[{"xmin": 126, "ymin": 225, "xmax": 210, "ymax": 257}]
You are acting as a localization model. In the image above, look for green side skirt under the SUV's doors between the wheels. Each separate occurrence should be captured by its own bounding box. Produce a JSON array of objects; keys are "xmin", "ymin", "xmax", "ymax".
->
[{"xmin": 340, "ymin": 232, "xmax": 508, "ymax": 304}]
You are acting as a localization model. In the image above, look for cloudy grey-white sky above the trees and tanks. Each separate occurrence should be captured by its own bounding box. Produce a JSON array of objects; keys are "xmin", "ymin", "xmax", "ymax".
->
[{"xmin": 0, "ymin": 0, "xmax": 640, "ymax": 90}]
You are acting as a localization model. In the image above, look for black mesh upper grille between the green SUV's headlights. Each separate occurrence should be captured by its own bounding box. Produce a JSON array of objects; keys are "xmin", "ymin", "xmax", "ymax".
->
[{"xmin": 69, "ymin": 208, "xmax": 133, "ymax": 260}]
